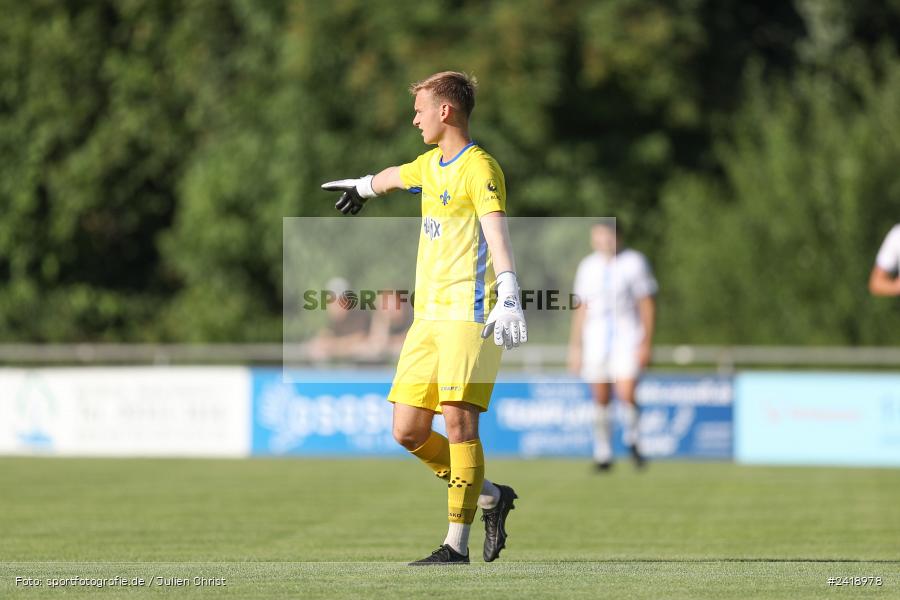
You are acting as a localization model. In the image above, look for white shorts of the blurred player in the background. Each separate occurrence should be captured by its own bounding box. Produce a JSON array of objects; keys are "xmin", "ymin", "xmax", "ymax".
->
[{"xmin": 581, "ymin": 331, "xmax": 641, "ymax": 383}]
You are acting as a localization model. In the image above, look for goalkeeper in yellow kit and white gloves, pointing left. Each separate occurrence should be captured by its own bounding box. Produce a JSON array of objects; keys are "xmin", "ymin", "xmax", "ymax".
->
[{"xmin": 322, "ymin": 72, "xmax": 528, "ymax": 565}]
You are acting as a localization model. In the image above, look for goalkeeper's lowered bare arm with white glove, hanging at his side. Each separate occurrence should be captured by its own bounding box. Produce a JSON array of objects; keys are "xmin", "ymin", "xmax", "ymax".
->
[{"xmin": 480, "ymin": 211, "xmax": 528, "ymax": 350}]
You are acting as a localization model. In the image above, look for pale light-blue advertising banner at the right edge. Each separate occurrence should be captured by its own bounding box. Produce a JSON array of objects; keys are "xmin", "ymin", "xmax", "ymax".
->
[{"xmin": 735, "ymin": 373, "xmax": 900, "ymax": 466}]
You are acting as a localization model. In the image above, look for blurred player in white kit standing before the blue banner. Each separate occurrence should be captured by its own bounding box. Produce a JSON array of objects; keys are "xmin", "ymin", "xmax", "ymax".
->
[{"xmin": 569, "ymin": 220, "xmax": 657, "ymax": 472}]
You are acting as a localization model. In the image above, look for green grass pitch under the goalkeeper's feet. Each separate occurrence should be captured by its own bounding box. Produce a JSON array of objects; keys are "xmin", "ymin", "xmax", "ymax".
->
[{"xmin": 0, "ymin": 458, "xmax": 900, "ymax": 600}]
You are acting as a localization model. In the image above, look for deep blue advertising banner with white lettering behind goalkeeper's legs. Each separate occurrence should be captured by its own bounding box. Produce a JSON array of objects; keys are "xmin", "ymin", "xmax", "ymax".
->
[{"xmin": 252, "ymin": 369, "xmax": 732, "ymax": 459}]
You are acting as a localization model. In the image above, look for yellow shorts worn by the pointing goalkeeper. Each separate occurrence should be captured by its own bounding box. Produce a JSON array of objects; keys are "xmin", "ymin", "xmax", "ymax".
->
[{"xmin": 388, "ymin": 319, "xmax": 502, "ymax": 412}]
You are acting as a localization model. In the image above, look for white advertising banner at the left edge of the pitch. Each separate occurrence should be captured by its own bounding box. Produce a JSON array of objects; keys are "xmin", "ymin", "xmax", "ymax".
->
[{"xmin": 0, "ymin": 367, "xmax": 251, "ymax": 456}]
